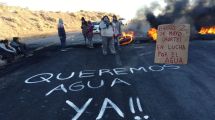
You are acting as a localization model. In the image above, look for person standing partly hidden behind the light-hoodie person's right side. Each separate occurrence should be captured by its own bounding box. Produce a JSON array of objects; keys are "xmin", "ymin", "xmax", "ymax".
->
[{"xmin": 112, "ymin": 15, "xmax": 122, "ymax": 50}]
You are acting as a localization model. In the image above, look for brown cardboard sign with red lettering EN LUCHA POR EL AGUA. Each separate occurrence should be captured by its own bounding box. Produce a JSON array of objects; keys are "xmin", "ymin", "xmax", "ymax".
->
[{"xmin": 155, "ymin": 24, "xmax": 190, "ymax": 64}]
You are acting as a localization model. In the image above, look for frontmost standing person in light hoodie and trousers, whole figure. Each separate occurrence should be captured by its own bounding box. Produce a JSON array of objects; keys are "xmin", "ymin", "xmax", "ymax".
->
[{"xmin": 99, "ymin": 16, "xmax": 116, "ymax": 55}]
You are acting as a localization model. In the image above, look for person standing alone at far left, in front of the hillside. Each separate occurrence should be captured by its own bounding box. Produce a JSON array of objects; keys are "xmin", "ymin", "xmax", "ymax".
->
[{"xmin": 58, "ymin": 18, "xmax": 66, "ymax": 48}]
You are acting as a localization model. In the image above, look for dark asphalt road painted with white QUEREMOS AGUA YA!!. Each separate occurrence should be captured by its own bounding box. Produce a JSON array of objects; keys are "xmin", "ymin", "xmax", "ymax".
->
[{"xmin": 0, "ymin": 34, "xmax": 215, "ymax": 120}]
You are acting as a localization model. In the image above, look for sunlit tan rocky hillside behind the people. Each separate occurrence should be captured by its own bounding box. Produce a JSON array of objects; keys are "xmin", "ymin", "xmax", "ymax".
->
[{"xmin": 0, "ymin": 5, "xmax": 116, "ymax": 39}]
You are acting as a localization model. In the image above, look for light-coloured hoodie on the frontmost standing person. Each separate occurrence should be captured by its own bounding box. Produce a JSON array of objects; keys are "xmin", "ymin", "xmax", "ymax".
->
[{"xmin": 99, "ymin": 20, "xmax": 114, "ymax": 37}]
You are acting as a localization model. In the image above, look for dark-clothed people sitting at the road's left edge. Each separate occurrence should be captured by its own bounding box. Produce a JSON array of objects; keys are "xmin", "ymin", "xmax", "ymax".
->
[{"xmin": 0, "ymin": 37, "xmax": 27, "ymax": 63}]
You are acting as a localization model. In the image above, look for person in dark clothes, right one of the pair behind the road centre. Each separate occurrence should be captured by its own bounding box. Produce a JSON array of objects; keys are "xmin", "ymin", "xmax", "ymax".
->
[{"xmin": 87, "ymin": 21, "xmax": 93, "ymax": 48}]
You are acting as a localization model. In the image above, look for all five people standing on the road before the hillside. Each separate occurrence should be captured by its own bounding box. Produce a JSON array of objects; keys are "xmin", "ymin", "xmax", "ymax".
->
[{"xmin": 58, "ymin": 15, "xmax": 122, "ymax": 55}]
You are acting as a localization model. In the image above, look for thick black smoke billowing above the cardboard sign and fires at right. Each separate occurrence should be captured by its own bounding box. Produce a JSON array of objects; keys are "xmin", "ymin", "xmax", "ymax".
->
[{"xmin": 143, "ymin": 0, "xmax": 215, "ymax": 31}]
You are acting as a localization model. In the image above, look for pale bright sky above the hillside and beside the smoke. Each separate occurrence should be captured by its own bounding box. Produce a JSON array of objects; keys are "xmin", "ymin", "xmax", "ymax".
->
[{"xmin": 0, "ymin": 0, "xmax": 165, "ymax": 19}]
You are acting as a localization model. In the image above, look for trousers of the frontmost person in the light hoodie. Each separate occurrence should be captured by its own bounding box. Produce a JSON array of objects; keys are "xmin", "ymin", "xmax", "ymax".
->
[{"xmin": 102, "ymin": 36, "xmax": 116, "ymax": 54}]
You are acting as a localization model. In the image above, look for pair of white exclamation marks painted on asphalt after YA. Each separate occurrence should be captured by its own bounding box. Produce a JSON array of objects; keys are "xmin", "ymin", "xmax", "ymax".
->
[{"xmin": 129, "ymin": 97, "xmax": 149, "ymax": 120}]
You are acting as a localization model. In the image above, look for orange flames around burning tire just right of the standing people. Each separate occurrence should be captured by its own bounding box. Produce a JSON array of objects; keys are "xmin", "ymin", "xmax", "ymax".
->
[{"xmin": 119, "ymin": 31, "xmax": 134, "ymax": 45}]
